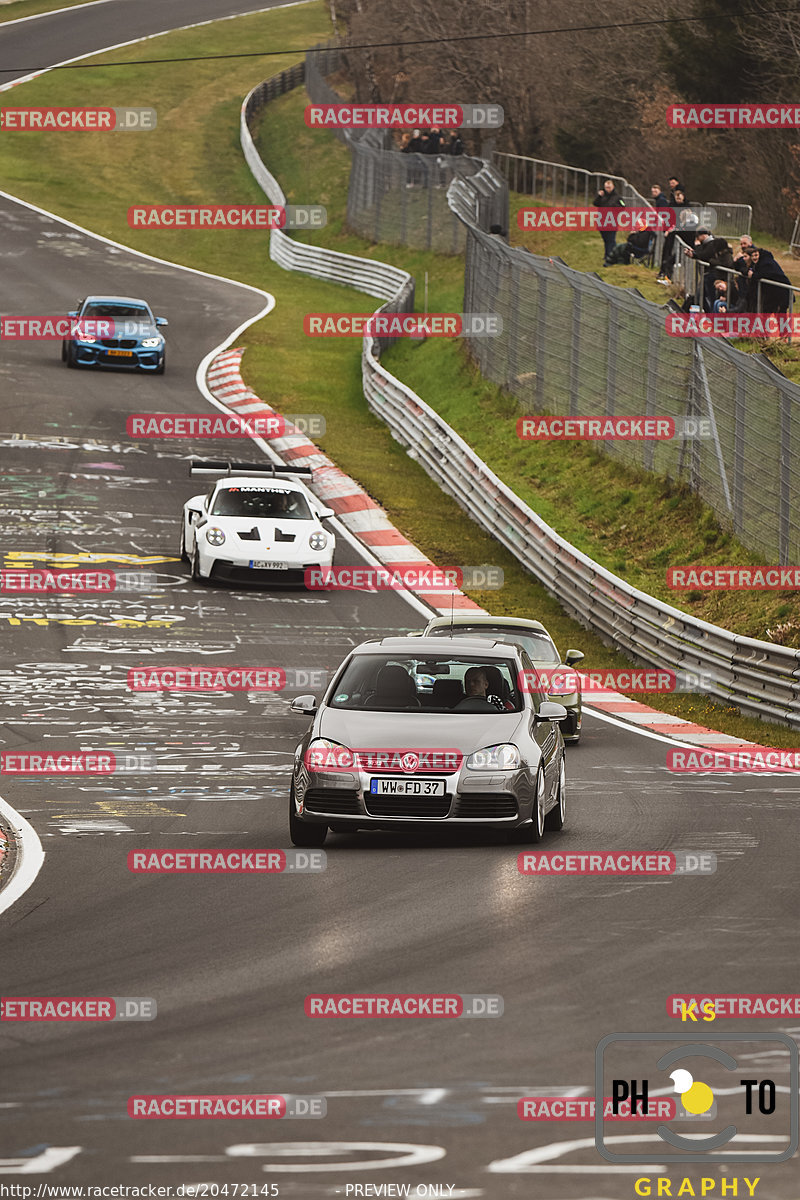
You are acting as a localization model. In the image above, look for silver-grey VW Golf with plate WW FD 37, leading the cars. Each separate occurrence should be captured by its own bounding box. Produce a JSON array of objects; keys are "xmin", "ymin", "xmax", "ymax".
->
[{"xmin": 289, "ymin": 637, "xmax": 566, "ymax": 846}]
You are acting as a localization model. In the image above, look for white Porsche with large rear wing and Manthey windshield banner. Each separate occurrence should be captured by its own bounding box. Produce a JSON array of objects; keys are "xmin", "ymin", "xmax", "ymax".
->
[{"xmin": 180, "ymin": 458, "xmax": 336, "ymax": 583}]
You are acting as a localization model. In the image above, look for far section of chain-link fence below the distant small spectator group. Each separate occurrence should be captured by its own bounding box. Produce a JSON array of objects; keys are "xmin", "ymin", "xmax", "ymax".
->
[{"xmin": 305, "ymin": 46, "xmax": 509, "ymax": 254}]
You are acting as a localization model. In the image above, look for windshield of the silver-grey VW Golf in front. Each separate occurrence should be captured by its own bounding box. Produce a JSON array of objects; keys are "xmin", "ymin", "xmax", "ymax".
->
[{"xmin": 329, "ymin": 654, "xmax": 523, "ymax": 716}]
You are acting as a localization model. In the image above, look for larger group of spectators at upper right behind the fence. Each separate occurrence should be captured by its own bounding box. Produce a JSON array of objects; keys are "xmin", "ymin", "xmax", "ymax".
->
[{"xmin": 594, "ymin": 175, "xmax": 792, "ymax": 313}]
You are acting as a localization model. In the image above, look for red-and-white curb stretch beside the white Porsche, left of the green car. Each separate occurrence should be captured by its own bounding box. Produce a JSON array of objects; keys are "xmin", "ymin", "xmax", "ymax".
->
[{"xmin": 206, "ymin": 348, "xmax": 485, "ymax": 613}]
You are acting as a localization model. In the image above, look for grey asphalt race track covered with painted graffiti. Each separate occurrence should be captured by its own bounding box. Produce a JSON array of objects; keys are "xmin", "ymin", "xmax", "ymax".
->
[{"xmin": 0, "ymin": 0, "xmax": 800, "ymax": 1200}]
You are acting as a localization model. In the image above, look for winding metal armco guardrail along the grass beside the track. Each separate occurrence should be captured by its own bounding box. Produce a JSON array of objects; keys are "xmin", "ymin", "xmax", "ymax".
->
[{"xmin": 241, "ymin": 60, "xmax": 800, "ymax": 728}]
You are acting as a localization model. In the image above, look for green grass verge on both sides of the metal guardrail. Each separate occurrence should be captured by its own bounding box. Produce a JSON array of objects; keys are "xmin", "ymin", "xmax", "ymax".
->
[{"xmin": 0, "ymin": 5, "xmax": 796, "ymax": 745}]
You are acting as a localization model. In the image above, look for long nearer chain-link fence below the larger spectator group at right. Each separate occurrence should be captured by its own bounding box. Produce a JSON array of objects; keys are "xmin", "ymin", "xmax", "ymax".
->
[{"xmin": 449, "ymin": 164, "xmax": 800, "ymax": 564}]
